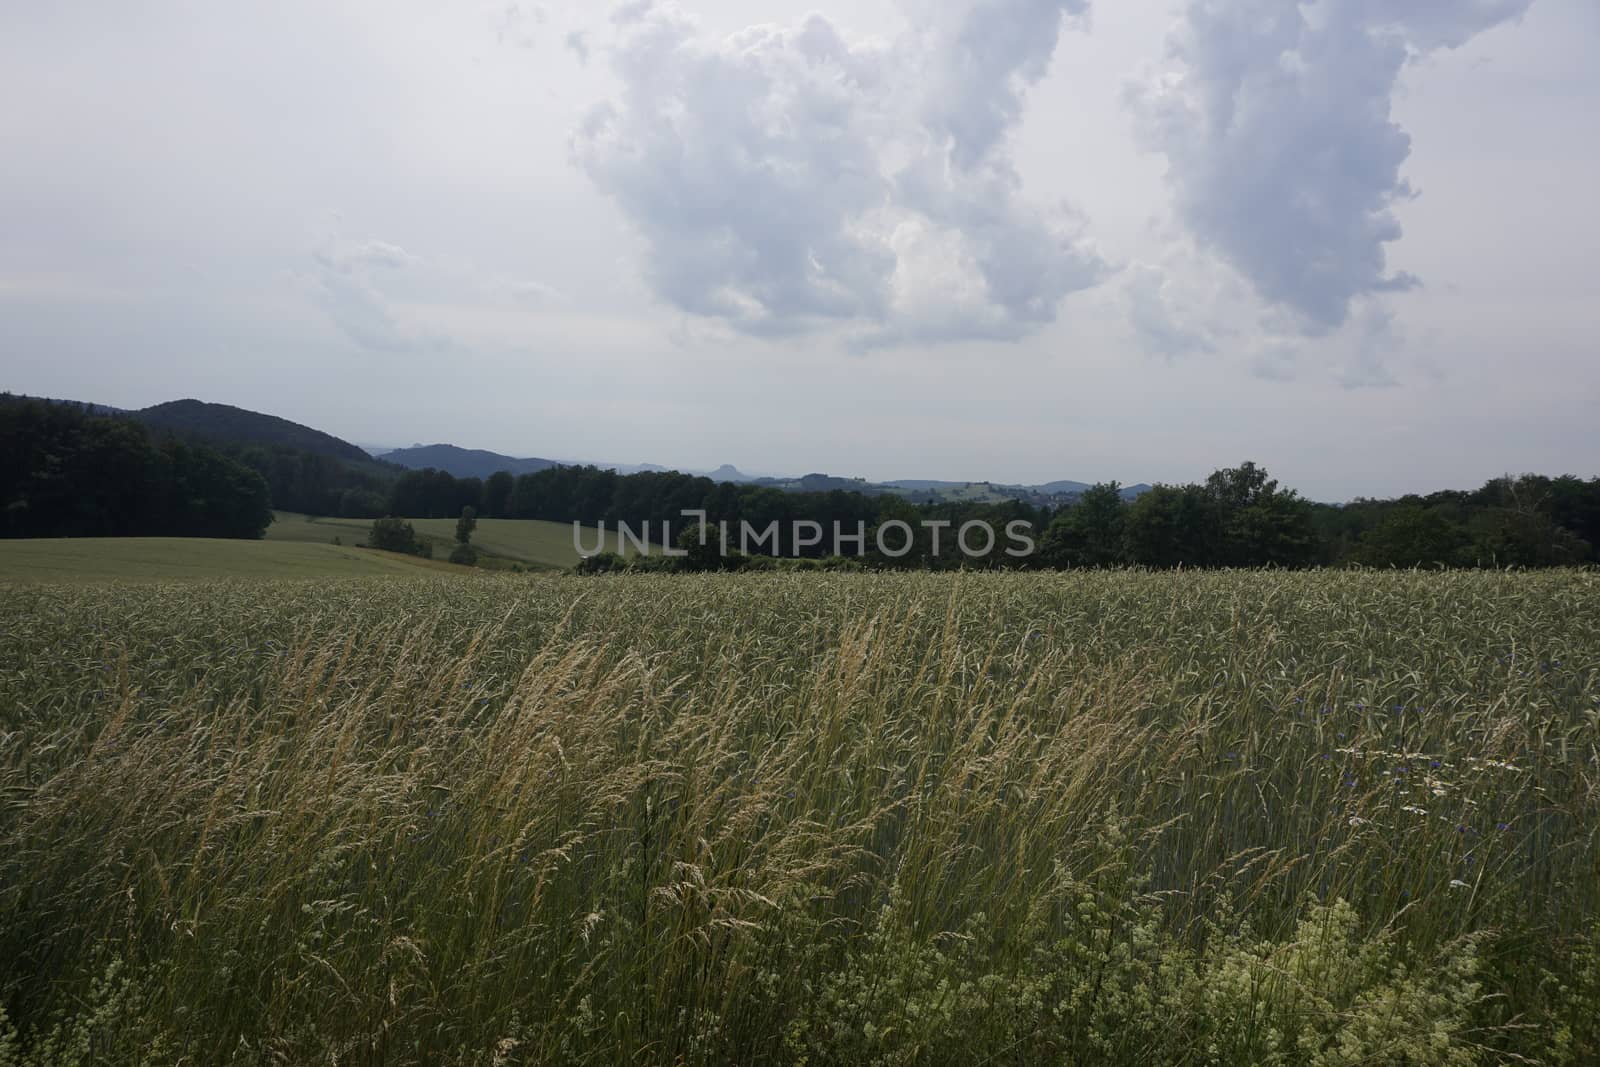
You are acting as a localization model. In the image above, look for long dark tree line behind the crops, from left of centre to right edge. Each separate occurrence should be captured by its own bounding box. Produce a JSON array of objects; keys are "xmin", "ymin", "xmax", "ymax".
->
[{"xmin": 389, "ymin": 462, "xmax": 1600, "ymax": 569}]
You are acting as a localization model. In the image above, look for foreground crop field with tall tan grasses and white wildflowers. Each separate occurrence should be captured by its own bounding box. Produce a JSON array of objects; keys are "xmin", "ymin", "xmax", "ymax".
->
[{"xmin": 0, "ymin": 571, "xmax": 1600, "ymax": 1065}]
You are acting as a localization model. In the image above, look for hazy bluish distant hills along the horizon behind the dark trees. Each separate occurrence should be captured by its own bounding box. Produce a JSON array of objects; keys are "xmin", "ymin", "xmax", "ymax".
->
[{"xmin": 25, "ymin": 400, "xmax": 1150, "ymax": 504}]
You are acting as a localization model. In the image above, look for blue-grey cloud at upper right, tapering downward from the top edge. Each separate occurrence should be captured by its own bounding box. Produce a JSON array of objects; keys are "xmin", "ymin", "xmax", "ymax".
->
[{"xmin": 1131, "ymin": 0, "xmax": 1531, "ymax": 334}]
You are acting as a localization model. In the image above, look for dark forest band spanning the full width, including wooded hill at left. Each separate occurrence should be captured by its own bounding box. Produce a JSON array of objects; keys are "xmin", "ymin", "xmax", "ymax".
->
[{"xmin": 0, "ymin": 395, "xmax": 1600, "ymax": 568}]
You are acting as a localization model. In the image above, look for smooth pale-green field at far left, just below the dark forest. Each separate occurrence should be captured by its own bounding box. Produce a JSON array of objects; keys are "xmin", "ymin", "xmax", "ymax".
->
[{"xmin": 0, "ymin": 537, "xmax": 466, "ymax": 582}]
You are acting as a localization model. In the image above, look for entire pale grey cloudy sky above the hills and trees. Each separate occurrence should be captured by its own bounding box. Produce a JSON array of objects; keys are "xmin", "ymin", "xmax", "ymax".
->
[{"xmin": 0, "ymin": 0, "xmax": 1600, "ymax": 501}]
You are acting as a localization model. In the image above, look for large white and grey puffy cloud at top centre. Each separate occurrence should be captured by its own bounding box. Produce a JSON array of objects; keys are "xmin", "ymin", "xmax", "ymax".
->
[{"xmin": 573, "ymin": 0, "xmax": 1106, "ymax": 346}]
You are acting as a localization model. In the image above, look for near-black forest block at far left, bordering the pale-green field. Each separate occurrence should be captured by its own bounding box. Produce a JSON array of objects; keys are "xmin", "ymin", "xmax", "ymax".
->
[{"xmin": 0, "ymin": 397, "xmax": 272, "ymax": 537}]
